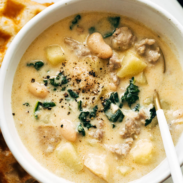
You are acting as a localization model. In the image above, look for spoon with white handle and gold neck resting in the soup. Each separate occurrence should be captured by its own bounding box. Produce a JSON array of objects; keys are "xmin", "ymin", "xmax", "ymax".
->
[{"xmin": 154, "ymin": 90, "xmax": 183, "ymax": 183}]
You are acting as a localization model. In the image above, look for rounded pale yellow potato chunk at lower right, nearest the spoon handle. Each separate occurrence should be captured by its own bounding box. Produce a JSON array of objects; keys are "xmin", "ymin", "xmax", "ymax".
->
[{"xmin": 130, "ymin": 139, "xmax": 153, "ymax": 164}]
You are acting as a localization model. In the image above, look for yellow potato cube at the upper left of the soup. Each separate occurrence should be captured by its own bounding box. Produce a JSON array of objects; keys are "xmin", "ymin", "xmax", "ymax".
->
[{"xmin": 45, "ymin": 45, "xmax": 65, "ymax": 65}]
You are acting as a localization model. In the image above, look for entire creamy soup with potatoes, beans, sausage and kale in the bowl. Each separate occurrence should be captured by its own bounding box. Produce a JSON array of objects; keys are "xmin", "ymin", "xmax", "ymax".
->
[{"xmin": 12, "ymin": 13, "xmax": 183, "ymax": 183}]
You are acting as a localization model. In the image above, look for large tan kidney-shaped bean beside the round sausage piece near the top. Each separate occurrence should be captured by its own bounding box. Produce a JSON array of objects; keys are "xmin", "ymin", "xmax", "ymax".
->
[{"xmin": 87, "ymin": 32, "xmax": 113, "ymax": 59}]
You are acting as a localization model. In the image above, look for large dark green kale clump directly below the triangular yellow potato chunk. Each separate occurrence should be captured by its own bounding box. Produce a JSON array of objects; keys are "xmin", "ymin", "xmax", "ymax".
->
[{"xmin": 121, "ymin": 77, "xmax": 140, "ymax": 107}]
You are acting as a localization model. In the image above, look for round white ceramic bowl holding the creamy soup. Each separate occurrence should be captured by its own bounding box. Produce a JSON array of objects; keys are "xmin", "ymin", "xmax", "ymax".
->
[{"xmin": 0, "ymin": 0, "xmax": 183, "ymax": 183}]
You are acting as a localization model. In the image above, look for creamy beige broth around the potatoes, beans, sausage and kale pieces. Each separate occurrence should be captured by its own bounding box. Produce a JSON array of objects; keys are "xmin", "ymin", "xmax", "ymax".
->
[{"xmin": 12, "ymin": 13, "xmax": 183, "ymax": 183}]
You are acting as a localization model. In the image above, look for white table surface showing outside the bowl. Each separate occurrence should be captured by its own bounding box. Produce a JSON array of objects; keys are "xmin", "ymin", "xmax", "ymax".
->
[{"xmin": 3, "ymin": 0, "xmax": 183, "ymax": 183}]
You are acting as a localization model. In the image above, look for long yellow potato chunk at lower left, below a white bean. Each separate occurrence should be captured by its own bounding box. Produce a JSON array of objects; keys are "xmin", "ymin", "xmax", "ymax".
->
[{"xmin": 56, "ymin": 143, "xmax": 83, "ymax": 172}]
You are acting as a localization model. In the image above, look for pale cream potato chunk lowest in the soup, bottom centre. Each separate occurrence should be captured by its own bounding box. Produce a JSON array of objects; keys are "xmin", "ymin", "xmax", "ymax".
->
[{"xmin": 84, "ymin": 154, "xmax": 109, "ymax": 180}]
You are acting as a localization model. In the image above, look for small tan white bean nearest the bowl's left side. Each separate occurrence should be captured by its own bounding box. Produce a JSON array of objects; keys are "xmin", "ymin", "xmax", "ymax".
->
[{"xmin": 29, "ymin": 82, "xmax": 48, "ymax": 98}]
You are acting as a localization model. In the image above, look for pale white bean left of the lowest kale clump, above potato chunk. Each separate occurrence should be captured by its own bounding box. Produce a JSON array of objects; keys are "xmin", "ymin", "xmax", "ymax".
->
[{"xmin": 59, "ymin": 119, "xmax": 77, "ymax": 142}]
